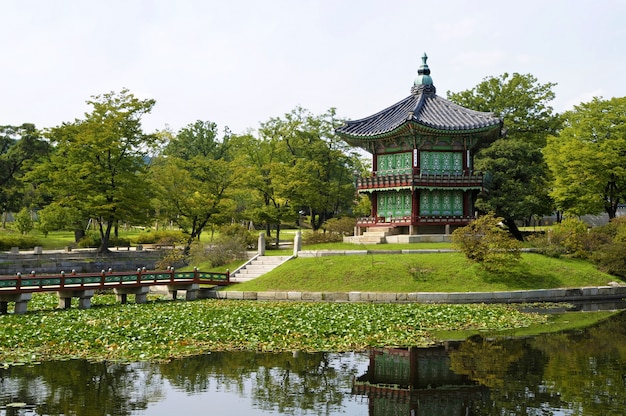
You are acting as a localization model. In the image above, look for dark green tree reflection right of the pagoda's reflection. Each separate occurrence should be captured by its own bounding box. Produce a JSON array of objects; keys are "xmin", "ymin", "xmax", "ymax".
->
[{"xmin": 450, "ymin": 313, "xmax": 626, "ymax": 416}]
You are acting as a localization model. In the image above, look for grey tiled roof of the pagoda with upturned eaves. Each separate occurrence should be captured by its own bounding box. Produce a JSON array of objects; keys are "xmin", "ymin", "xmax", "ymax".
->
[{"xmin": 337, "ymin": 85, "xmax": 501, "ymax": 139}]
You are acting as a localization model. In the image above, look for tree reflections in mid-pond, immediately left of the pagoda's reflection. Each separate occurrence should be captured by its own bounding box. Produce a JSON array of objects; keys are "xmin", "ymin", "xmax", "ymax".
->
[{"xmin": 161, "ymin": 352, "xmax": 358, "ymax": 414}]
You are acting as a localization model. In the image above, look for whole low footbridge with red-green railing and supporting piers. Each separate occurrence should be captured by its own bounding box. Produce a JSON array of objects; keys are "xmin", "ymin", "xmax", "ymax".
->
[{"xmin": 0, "ymin": 269, "xmax": 235, "ymax": 314}]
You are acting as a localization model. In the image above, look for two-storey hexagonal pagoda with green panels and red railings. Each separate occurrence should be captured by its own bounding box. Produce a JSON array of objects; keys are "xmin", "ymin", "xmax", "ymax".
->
[{"xmin": 336, "ymin": 54, "xmax": 503, "ymax": 242}]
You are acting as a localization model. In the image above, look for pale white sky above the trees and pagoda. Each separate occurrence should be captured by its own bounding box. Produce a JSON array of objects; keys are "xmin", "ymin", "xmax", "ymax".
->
[{"xmin": 0, "ymin": 0, "xmax": 626, "ymax": 133}]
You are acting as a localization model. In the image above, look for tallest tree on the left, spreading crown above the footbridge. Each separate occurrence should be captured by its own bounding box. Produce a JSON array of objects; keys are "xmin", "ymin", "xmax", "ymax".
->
[{"xmin": 37, "ymin": 89, "xmax": 157, "ymax": 253}]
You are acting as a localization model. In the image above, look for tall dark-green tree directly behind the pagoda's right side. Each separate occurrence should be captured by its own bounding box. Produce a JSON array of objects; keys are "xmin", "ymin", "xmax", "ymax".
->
[{"xmin": 448, "ymin": 73, "xmax": 561, "ymax": 240}]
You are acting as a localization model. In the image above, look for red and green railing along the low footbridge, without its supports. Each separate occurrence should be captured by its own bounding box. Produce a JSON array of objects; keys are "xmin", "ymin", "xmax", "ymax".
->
[{"xmin": 0, "ymin": 269, "xmax": 235, "ymax": 295}]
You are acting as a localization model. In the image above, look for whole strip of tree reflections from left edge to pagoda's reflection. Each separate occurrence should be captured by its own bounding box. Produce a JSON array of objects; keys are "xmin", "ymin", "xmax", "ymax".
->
[{"xmin": 0, "ymin": 352, "xmax": 359, "ymax": 415}]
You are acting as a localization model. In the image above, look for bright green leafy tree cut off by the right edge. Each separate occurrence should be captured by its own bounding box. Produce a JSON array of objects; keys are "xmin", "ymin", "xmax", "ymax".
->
[{"xmin": 545, "ymin": 97, "xmax": 626, "ymax": 218}]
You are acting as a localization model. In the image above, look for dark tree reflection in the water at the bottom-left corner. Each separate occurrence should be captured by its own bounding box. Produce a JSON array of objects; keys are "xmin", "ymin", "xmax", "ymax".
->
[{"xmin": 0, "ymin": 360, "xmax": 162, "ymax": 415}]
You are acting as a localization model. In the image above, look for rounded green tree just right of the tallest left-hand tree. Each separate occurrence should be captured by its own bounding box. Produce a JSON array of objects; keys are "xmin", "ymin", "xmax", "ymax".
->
[{"xmin": 152, "ymin": 121, "xmax": 239, "ymax": 254}]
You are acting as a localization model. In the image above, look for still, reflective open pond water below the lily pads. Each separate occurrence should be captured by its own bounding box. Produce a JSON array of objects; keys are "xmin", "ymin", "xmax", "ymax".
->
[{"xmin": 0, "ymin": 312, "xmax": 626, "ymax": 416}]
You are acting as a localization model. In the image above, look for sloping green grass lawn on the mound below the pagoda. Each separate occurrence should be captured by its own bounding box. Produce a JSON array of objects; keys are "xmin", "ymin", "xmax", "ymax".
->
[{"xmin": 227, "ymin": 253, "xmax": 618, "ymax": 292}]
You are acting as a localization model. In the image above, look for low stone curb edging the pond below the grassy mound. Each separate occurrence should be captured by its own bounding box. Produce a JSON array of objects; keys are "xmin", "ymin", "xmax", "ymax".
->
[{"xmin": 207, "ymin": 285, "xmax": 626, "ymax": 303}]
